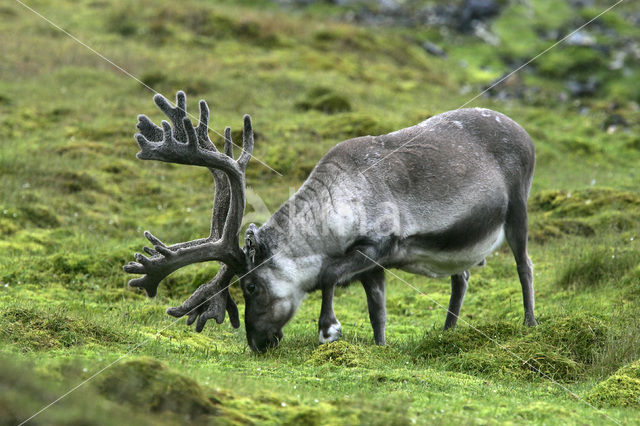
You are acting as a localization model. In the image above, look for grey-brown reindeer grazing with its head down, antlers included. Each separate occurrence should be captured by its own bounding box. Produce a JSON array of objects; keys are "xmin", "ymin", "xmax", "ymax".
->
[{"xmin": 124, "ymin": 92, "xmax": 536, "ymax": 351}]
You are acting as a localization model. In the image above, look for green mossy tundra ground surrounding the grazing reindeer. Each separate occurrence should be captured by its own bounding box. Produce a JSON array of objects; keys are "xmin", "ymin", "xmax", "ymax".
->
[{"xmin": 0, "ymin": 0, "xmax": 640, "ymax": 425}]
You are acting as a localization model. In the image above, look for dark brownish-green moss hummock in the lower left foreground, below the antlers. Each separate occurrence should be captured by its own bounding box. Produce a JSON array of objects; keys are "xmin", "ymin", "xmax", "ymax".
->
[{"xmin": 97, "ymin": 358, "xmax": 217, "ymax": 419}]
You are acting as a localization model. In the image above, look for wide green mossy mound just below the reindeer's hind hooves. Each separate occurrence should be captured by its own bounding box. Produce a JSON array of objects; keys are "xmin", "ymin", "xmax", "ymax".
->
[{"xmin": 414, "ymin": 314, "xmax": 607, "ymax": 381}]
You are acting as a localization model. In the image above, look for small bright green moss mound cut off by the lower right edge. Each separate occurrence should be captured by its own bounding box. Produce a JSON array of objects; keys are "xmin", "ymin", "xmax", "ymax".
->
[{"xmin": 586, "ymin": 361, "xmax": 640, "ymax": 407}]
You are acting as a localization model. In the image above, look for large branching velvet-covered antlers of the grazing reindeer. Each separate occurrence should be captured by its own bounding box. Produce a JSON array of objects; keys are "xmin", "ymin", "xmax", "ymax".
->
[{"xmin": 124, "ymin": 91, "xmax": 253, "ymax": 331}]
